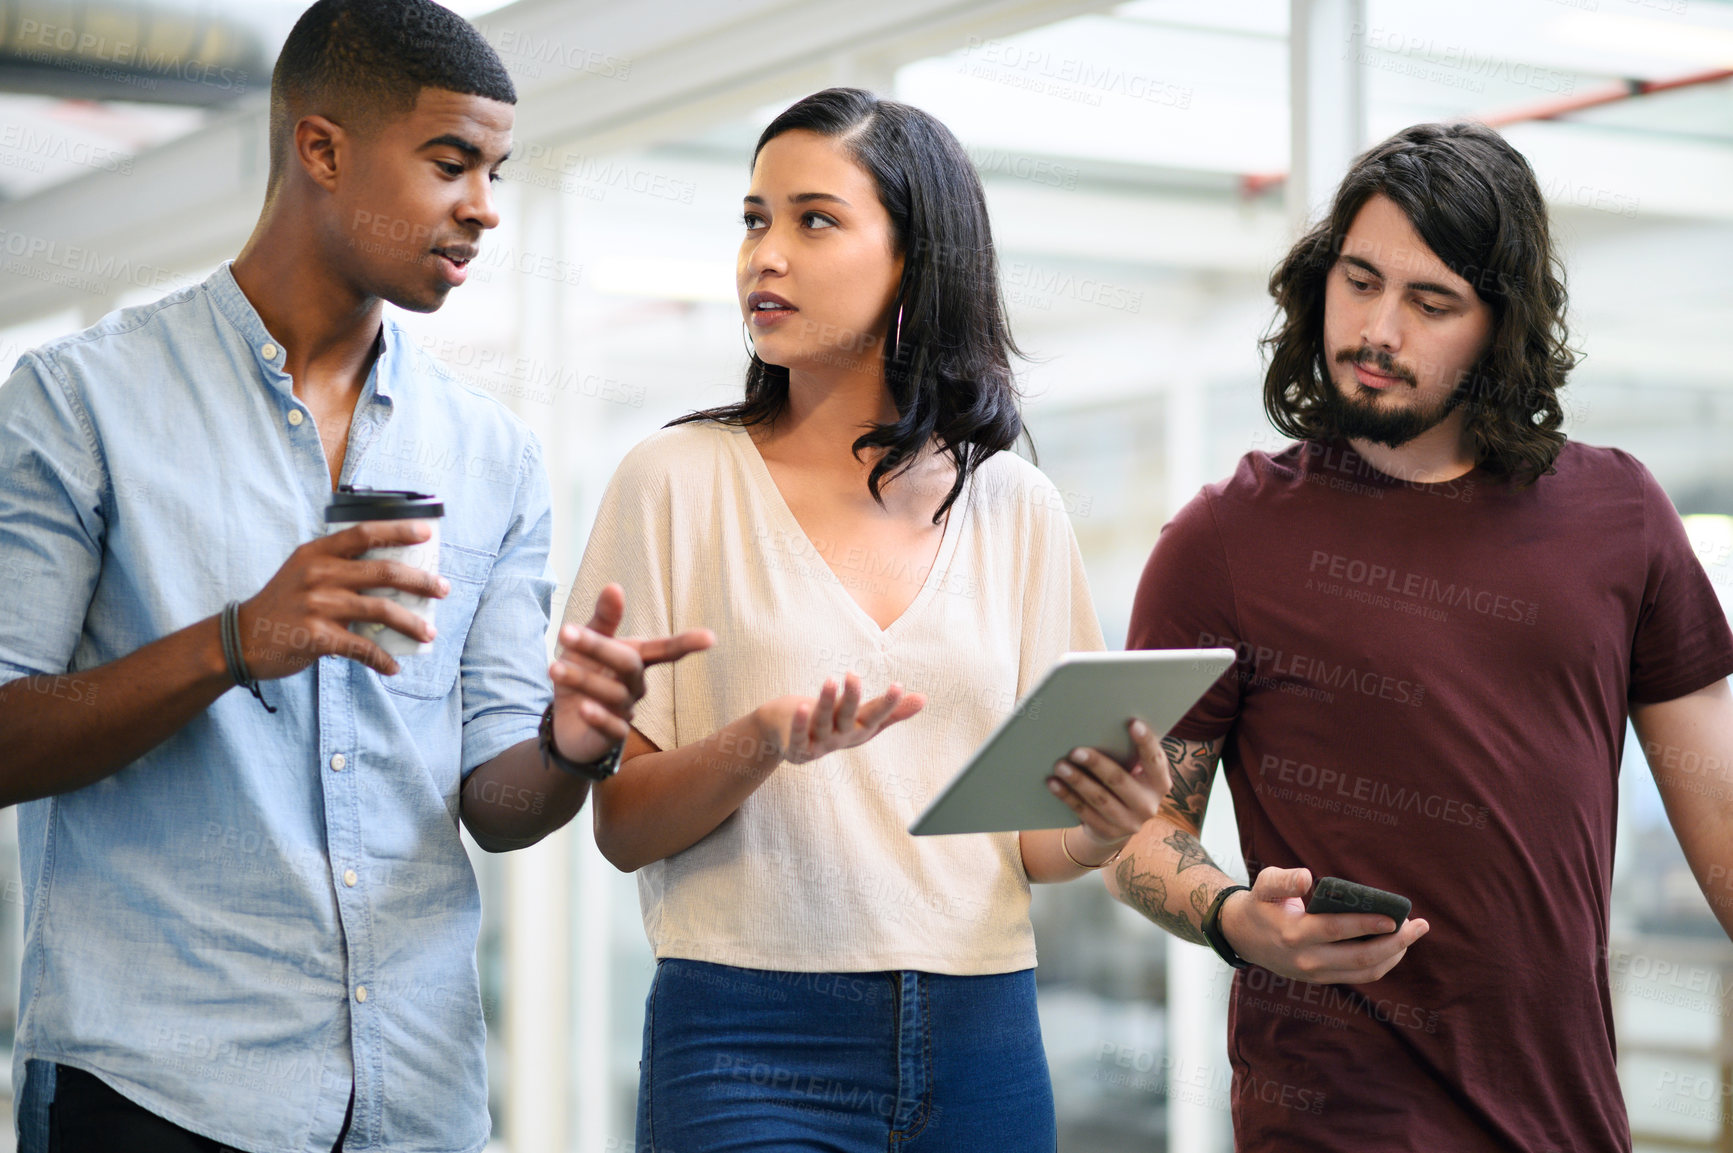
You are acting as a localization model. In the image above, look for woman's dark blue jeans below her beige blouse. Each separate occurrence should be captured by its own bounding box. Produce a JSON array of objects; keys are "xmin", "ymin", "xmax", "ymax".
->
[{"xmin": 636, "ymin": 959, "xmax": 1057, "ymax": 1153}]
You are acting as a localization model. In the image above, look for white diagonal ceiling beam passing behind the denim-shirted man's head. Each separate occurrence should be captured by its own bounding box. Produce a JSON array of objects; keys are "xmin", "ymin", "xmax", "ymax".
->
[{"xmin": 0, "ymin": 0, "xmax": 1111, "ymax": 326}]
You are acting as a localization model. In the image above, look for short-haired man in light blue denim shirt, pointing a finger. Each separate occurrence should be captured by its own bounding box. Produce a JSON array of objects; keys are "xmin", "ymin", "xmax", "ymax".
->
[{"xmin": 0, "ymin": 0, "xmax": 707, "ymax": 1153}]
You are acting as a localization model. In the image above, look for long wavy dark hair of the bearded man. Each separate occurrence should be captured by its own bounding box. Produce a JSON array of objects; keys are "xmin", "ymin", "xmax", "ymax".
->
[{"xmin": 1262, "ymin": 121, "xmax": 1577, "ymax": 484}]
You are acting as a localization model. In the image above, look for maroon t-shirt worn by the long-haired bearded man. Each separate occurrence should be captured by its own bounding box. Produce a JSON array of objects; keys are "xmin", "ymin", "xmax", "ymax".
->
[{"xmin": 1126, "ymin": 442, "xmax": 1733, "ymax": 1153}]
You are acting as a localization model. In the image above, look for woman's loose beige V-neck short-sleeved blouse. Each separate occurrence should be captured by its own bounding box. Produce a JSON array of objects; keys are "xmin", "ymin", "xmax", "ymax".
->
[{"xmin": 565, "ymin": 423, "xmax": 1102, "ymax": 974}]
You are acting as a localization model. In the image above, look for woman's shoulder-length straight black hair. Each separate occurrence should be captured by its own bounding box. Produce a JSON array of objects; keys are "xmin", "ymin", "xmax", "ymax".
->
[{"xmin": 671, "ymin": 88, "xmax": 1024, "ymax": 524}]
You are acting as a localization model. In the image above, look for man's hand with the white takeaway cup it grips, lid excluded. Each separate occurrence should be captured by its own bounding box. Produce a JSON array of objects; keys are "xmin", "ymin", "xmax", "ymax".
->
[{"xmin": 241, "ymin": 488, "xmax": 451, "ymax": 680}]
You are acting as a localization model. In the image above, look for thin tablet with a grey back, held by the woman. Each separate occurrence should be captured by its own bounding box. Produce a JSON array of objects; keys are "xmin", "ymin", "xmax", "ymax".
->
[{"xmin": 908, "ymin": 648, "xmax": 1234, "ymax": 836}]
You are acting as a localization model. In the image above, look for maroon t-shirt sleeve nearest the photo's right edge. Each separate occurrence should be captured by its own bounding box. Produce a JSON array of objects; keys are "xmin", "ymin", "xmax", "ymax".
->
[{"xmin": 1631, "ymin": 465, "xmax": 1733, "ymax": 704}]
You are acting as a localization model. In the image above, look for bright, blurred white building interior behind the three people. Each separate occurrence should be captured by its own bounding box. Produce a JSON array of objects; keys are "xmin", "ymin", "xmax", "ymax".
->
[{"xmin": 0, "ymin": 0, "xmax": 1733, "ymax": 1153}]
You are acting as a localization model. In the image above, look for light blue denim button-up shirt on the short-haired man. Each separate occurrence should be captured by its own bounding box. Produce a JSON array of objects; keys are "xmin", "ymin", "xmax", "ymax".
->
[{"xmin": 0, "ymin": 265, "xmax": 553, "ymax": 1153}]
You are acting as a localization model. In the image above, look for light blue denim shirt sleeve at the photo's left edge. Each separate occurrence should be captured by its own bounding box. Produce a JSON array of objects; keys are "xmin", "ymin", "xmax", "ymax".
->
[{"xmin": 0, "ymin": 355, "xmax": 107, "ymax": 683}]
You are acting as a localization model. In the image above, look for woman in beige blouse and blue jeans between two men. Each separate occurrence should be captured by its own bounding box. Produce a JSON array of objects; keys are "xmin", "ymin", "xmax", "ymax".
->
[{"xmin": 568, "ymin": 88, "xmax": 1166, "ymax": 1153}]
